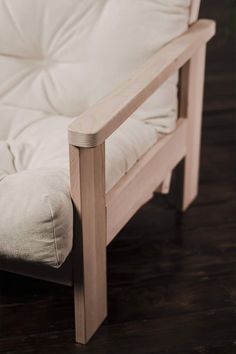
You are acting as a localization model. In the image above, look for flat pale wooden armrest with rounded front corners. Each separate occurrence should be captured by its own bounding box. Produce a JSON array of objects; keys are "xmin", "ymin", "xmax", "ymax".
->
[{"xmin": 69, "ymin": 20, "xmax": 215, "ymax": 148}]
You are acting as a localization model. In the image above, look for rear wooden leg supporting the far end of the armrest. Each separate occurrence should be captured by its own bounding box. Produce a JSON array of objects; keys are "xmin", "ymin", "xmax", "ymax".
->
[{"xmin": 180, "ymin": 45, "xmax": 206, "ymax": 210}]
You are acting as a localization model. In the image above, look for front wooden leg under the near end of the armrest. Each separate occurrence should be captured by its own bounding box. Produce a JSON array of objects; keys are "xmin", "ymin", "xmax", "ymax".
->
[{"xmin": 70, "ymin": 144, "xmax": 107, "ymax": 344}]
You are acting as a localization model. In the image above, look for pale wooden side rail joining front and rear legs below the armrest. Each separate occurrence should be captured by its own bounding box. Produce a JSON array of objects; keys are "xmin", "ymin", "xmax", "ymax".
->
[{"xmin": 106, "ymin": 119, "xmax": 187, "ymax": 244}]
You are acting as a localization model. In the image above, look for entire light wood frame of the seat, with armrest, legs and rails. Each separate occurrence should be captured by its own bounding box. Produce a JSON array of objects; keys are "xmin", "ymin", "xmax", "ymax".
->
[{"xmin": 0, "ymin": 0, "xmax": 215, "ymax": 343}]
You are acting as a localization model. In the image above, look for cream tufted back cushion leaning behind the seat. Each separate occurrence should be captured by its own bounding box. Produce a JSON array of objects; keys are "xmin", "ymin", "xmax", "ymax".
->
[{"xmin": 0, "ymin": 0, "xmax": 191, "ymax": 139}]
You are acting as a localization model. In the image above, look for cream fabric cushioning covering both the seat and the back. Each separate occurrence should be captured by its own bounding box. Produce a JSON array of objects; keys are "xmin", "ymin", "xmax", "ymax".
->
[{"xmin": 0, "ymin": 0, "xmax": 191, "ymax": 267}]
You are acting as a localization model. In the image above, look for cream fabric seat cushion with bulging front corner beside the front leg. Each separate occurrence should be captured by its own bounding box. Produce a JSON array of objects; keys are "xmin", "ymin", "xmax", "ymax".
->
[{"xmin": 0, "ymin": 108, "xmax": 157, "ymax": 267}]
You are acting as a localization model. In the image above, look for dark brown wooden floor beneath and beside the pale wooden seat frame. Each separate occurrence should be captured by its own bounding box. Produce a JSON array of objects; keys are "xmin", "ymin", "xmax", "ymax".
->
[{"xmin": 0, "ymin": 0, "xmax": 236, "ymax": 354}]
